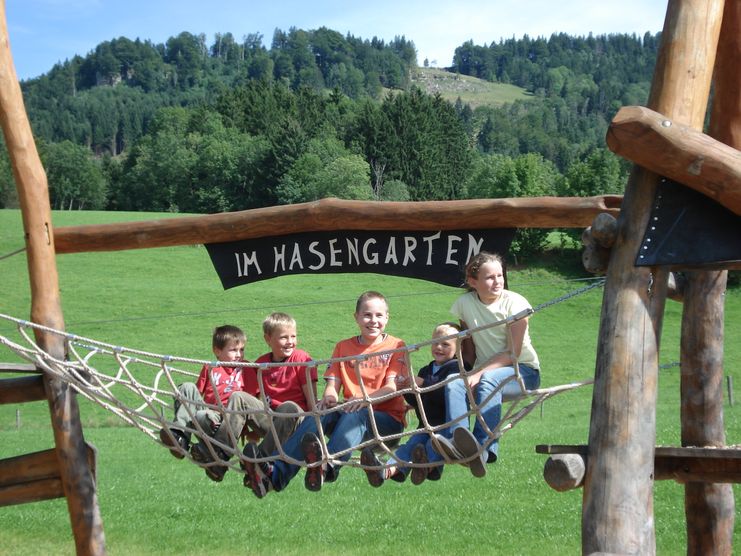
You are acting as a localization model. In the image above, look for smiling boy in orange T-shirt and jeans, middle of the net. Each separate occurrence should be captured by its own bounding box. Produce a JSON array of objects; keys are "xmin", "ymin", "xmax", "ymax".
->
[{"xmin": 242, "ymin": 291, "xmax": 408, "ymax": 498}]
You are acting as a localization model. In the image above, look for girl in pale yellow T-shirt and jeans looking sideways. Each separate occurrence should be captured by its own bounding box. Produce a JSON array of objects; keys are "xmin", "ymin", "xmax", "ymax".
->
[{"xmin": 436, "ymin": 251, "xmax": 540, "ymax": 477}]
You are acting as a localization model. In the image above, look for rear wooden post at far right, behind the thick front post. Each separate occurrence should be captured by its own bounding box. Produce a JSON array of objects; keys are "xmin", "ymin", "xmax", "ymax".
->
[{"xmin": 681, "ymin": 0, "xmax": 741, "ymax": 555}]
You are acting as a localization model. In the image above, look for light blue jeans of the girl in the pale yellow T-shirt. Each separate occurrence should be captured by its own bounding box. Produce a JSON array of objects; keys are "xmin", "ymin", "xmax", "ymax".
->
[{"xmin": 434, "ymin": 364, "xmax": 540, "ymax": 461}]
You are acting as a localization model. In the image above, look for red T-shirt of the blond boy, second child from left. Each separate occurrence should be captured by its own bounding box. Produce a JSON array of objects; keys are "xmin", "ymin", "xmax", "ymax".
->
[{"xmin": 244, "ymin": 349, "xmax": 317, "ymax": 411}]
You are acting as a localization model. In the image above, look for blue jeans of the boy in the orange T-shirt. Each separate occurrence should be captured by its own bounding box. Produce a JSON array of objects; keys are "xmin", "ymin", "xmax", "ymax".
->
[{"xmin": 272, "ymin": 407, "xmax": 404, "ymax": 490}]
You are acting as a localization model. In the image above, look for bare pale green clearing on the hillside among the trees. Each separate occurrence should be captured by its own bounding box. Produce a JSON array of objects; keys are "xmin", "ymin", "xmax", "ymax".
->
[{"xmin": 412, "ymin": 67, "xmax": 532, "ymax": 109}]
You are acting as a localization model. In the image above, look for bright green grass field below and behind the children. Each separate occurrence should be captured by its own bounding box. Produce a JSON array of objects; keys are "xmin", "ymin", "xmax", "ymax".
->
[{"xmin": 0, "ymin": 210, "xmax": 741, "ymax": 555}]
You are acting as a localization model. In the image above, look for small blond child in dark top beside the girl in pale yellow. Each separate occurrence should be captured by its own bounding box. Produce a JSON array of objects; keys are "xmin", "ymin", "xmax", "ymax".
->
[{"xmin": 360, "ymin": 322, "xmax": 460, "ymax": 487}]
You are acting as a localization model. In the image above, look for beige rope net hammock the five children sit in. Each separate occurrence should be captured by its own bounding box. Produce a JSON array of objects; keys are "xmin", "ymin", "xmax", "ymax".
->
[{"xmin": 0, "ymin": 282, "xmax": 602, "ymax": 475}]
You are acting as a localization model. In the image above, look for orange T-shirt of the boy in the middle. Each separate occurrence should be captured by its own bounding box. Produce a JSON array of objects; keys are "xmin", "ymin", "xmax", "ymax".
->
[{"xmin": 324, "ymin": 334, "xmax": 409, "ymax": 423}]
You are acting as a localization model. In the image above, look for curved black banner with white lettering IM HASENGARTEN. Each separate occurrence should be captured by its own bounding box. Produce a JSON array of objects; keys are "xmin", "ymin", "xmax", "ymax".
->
[{"xmin": 206, "ymin": 228, "xmax": 515, "ymax": 290}]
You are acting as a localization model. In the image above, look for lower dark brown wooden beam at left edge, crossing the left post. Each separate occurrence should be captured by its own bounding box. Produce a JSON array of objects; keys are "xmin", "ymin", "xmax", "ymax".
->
[{"xmin": 0, "ymin": 444, "xmax": 96, "ymax": 506}]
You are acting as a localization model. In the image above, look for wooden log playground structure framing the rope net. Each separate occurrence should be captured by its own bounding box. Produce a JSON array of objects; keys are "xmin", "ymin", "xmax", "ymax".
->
[{"xmin": 0, "ymin": 0, "xmax": 741, "ymax": 554}]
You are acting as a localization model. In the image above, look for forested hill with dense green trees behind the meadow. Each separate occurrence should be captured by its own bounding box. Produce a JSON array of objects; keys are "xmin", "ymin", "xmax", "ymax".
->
[{"xmin": 0, "ymin": 28, "xmax": 658, "ymax": 256}]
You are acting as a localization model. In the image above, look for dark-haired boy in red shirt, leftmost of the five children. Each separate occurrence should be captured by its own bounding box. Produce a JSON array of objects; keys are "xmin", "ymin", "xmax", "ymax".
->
[{"xmin": 159, "ymin": 325, "xmax": 262, "ymax": 481}]
